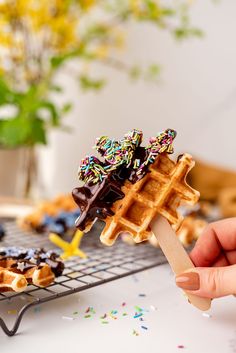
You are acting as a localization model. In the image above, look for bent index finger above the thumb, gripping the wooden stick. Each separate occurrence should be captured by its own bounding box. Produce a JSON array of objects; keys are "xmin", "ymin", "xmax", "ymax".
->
[{"xmin": 190, "ymin": 218, "xmax": 236, "ymax": 267}]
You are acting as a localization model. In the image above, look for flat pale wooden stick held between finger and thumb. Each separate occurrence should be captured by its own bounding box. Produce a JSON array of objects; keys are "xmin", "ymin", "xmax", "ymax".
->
[{"xmin": 151, "ymin": 215, "xmax": 211, "ymax": 311}]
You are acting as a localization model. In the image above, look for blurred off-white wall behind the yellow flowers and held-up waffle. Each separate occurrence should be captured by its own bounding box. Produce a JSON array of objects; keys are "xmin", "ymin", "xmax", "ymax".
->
[{"xmin": 40, "ymin": 0, "xmax": 236, "ymax": 196}]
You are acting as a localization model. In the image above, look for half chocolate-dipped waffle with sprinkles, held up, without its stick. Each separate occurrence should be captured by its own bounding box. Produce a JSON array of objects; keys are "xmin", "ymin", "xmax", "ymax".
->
[{"xmin": 72, "ymin": 129, "xmax": 199, "ymax": 245}]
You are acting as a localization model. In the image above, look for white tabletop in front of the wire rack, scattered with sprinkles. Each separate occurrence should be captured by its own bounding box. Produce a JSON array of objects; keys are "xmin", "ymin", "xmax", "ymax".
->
[{"xmin": 0, "ymin": 265, "xmax": 236, "ymax": 353}]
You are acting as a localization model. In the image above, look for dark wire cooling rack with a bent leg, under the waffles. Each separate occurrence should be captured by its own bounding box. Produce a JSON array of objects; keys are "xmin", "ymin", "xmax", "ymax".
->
[{"xmin": 0, "ymin": 221, "xmax": 166, "ymax": 336}]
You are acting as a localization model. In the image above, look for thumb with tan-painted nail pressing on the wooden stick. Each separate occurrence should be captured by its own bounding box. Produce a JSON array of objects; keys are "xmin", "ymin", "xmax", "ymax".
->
[{"xmin": 176, "ymin": 265, "xmax": 236, "ymax": 298}]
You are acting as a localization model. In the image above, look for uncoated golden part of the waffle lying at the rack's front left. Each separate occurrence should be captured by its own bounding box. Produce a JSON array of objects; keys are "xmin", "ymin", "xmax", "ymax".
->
[{"xmin": 0, "ymin": 259, "xmax": 55, "ymax": 292}]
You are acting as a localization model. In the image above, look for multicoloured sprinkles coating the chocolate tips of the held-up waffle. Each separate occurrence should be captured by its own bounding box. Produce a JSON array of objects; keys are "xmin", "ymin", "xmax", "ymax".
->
[{"xmin": 79, "ymin": 129, "xmax": 176, "ymax": 184}]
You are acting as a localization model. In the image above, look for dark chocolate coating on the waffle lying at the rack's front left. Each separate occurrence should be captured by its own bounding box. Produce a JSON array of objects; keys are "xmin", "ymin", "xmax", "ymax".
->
[{"xmin": 0, "ymin": 247, "xmax": 64, "ymax": 277}]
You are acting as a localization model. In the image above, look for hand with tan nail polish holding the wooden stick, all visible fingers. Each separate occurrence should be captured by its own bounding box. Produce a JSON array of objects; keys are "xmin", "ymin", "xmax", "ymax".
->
[{"xmin": 176, "ymin": 218, "xmax": 236, "ymax": 298}]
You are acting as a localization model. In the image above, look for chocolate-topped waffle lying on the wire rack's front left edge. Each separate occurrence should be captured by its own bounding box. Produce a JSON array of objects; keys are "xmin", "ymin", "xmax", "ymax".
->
[{"xmin": 0, "ymin": 247, "xmax": 64, "ymax": 292}]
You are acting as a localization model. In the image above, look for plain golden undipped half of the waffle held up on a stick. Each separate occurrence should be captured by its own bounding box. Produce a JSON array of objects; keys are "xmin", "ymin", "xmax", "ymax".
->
[{"xmin": 100, "ymin": 153, "xmax": 199, "ymax": 245}]
